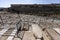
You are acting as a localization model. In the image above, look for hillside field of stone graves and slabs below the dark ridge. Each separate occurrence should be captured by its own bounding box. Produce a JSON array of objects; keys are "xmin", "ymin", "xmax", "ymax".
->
[{"xmin": 0, "ymin": 13, "xmax": 60, "ymax": 40}]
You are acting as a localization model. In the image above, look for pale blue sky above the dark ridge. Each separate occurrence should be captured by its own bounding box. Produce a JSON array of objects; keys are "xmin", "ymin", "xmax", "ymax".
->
[{"xmin": 0, "ymin": 0, "xmax": 60, "ymax": 7}]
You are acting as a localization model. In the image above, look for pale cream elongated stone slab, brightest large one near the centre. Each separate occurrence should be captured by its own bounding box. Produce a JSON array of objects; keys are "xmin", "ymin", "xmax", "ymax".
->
[{"xmin": 32, "ymin": 24, "xmax": 42, "ymax": 38}]
